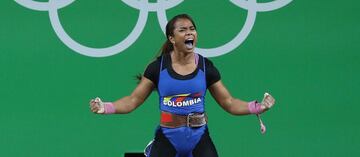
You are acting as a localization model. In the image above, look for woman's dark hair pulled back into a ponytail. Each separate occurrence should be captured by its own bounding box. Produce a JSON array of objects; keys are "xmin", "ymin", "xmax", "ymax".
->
[{"xmin": 135, "ymin": 14, "xmax": 196, "ymax": 83}]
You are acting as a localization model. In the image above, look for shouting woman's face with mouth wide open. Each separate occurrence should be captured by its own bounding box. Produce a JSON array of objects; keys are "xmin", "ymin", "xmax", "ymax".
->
[{"xmin": 169, "ymin": 19, "xmax": 197, "ymax": 53}]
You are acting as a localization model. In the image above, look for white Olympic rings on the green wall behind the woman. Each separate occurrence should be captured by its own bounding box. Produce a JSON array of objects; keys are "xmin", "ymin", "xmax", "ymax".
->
[{"xmin": 15, "ymin": 0, "xmax": 292, "ymax": 57}]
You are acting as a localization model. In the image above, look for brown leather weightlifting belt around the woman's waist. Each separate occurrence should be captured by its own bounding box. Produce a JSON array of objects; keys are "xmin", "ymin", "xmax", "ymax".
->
[{"xmin": 160, "ymin": 111, "xmax": 207, "ymax": 128}]
